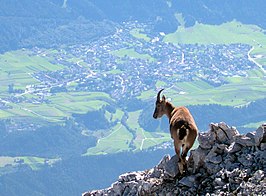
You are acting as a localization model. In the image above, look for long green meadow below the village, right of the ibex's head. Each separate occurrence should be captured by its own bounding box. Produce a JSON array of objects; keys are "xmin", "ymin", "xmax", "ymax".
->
[{"xmin": 139, "ymin": 74, "xmax": 266, "ymax": 106}]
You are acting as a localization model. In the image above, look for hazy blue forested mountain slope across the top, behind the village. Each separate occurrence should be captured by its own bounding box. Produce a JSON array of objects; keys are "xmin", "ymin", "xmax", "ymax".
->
[{"xmin": 0, "ymin": 0, "xmax": 266, "ymax": 52}]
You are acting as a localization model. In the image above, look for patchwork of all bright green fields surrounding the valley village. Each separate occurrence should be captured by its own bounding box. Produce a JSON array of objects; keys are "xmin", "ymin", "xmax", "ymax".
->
[{"xmin": 0, "ymin": 20, "xmax": 266, "ymax": 155}]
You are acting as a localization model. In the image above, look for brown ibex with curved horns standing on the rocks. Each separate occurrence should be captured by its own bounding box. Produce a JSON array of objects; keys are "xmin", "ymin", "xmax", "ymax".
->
[{"xmin": 153, "ymin": 89, "xmax": 198, "ymax": 174}]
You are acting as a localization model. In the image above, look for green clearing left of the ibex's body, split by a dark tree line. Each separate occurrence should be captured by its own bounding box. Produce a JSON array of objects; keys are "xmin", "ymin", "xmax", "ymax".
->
[{"xmin": 84, "ymin": 110, "xmax": 171, "ymax": 156}]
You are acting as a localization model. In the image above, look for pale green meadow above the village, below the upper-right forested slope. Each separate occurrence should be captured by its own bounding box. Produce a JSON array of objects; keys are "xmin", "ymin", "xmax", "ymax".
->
[{"xmin": 164, "ymin": 20, "xmax": 266, "ymax": 66}]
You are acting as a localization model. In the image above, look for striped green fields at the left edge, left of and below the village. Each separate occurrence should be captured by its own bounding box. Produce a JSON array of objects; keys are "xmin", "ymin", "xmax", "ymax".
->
[{"xmin": 0, "ymin": 50, "xmax": 113, "ymax": 124}]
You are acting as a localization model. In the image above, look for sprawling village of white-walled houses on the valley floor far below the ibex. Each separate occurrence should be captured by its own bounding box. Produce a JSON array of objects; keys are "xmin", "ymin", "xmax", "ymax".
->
[{"xmin": 5, "ymin": 22, "xmax": 256, "ymax": 103}]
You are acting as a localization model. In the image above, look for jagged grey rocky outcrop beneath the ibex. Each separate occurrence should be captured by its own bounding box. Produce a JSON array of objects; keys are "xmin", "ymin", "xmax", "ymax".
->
[{"xmin": 83, "ymin": 123, "xmax": 266, "ymax": 196}]
